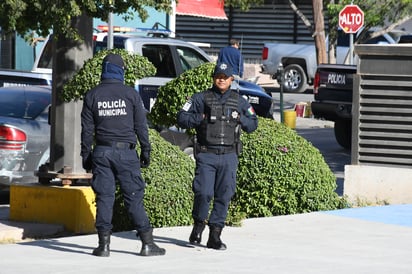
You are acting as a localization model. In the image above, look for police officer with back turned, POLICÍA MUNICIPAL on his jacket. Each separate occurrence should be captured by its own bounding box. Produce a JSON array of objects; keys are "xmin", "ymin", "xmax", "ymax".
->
[{"xmin": 81, "ymin": 54, "xmax": 166, "ymax": 257}]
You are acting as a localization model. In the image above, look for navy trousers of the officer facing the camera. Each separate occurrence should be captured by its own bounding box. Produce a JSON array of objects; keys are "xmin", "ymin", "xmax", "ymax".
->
[{"xmin": 192, "ymin": 152, "xmax": 239, "ymax": 228}]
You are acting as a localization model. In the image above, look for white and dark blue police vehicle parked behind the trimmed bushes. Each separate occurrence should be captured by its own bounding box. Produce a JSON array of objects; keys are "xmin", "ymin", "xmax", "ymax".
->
[{"xmin": 33, "ymin": 32, "xmax": 274, "ymax": 117}]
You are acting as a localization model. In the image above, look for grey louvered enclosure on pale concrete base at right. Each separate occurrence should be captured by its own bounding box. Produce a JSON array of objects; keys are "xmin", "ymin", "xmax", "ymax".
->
[{"xmin": 343, "ymin": 44, "xmax": 412, "ymax": 204}]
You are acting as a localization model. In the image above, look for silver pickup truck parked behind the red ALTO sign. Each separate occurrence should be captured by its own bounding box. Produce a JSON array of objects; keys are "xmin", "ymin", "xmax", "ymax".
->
[{"xmin": 261, "ymin": 29, "xmax": 404, "ymax": 92}]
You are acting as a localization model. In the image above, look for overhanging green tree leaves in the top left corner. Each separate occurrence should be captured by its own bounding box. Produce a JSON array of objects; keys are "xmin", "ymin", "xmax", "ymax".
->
[{"xmin": 0, "ymin": 0, "xmax": 172, "ymax": 38}]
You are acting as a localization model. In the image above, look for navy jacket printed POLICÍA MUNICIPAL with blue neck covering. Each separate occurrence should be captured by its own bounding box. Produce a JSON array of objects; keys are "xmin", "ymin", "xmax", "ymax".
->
[{"xmin": 81, "ymin": 64, "xmax": 150, "ymax": 156}]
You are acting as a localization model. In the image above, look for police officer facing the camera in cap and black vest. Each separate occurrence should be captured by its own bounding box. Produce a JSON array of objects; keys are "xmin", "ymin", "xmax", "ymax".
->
[{"xmin": 177, "ymin": 63, "xmax": 258, "ymax": 250}]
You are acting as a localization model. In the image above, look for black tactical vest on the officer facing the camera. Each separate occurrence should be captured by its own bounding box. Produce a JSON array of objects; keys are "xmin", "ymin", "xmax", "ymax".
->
[{"xmin": 197, "ymin": 90, "xmax": 240, "ymax": 146}]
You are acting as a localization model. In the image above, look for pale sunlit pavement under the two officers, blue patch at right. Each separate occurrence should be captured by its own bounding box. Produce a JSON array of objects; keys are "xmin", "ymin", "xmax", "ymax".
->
[{"xmin": 0, "ymin": 205, "xmax": 412, "ymax": 274}]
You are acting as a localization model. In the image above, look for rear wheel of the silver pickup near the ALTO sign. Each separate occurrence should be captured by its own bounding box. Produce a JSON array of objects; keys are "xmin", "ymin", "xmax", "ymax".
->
[{"xmin": 283, "ymin": 64, "xmax": 307, "ymax": 93}]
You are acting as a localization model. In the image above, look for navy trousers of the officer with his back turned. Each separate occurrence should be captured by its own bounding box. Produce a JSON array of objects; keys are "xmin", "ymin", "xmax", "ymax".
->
[{"xmin": 92, "ymin": 146, "xmax": 151, "ymax": 232}]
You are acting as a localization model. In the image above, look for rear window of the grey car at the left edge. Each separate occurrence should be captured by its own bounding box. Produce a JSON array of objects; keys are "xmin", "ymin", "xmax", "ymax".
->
[{"xmin": 0, "ymin": 90, "xmax": 50, "ymax": 119}]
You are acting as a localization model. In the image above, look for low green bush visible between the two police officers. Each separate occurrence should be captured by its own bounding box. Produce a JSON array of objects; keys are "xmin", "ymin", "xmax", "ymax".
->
[{"xmin": 113, "ymin": 129, "xmax": 195, "ymax": 231}]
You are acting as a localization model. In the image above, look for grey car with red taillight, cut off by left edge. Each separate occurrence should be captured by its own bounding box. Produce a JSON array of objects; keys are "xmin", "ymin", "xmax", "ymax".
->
[{"xmin": 0, "ymin": 85, "xmax": 51, "ymax": 188}]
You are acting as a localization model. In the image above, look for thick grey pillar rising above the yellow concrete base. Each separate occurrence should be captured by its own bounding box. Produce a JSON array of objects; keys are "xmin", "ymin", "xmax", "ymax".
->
[{"xmin": 49, "ymin": 15, "xmax": 93, "ymax": 173}]
